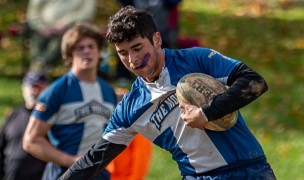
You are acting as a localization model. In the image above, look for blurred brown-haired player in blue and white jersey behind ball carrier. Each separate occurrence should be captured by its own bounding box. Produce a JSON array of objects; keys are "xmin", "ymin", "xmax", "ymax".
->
[{"xmin": 23, "ymin": 24, "xmax": 117, "ymax": 180}]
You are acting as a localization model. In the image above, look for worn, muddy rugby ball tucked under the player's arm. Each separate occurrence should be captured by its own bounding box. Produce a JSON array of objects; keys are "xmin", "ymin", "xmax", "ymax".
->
[{"xmin": 176, "ymin": 73, "xmax": 237, "ymax": 131}]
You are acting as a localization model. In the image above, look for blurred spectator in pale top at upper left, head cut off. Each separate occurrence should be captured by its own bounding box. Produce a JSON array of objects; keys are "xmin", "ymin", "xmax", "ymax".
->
[{"xmin": 26, "ymin": 0, "xmax": 96, "ymax": 70}]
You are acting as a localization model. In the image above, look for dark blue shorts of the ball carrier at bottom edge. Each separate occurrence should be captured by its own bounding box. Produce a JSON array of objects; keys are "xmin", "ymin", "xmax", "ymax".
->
[{"xmin": 182, "ymin": 157, "xmax": 276, "ymax": 180}]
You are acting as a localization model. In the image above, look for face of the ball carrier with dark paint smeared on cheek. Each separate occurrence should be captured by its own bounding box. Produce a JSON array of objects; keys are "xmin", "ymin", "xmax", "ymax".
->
[{"xmin": 115, "ymin": 32, "xmax": 164, "ymax": 82}]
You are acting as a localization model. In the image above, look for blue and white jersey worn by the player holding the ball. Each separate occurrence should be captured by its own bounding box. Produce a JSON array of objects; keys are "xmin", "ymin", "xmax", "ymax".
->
[{"xmin": 103, "ymin": 47, "xmax": 264, "ymax": 175}]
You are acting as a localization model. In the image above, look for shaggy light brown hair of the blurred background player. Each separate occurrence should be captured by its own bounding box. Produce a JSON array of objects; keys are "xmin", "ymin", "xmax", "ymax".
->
[{"xmin": 61, "ymin": 23, "xmax": 105, "ymax": 68}]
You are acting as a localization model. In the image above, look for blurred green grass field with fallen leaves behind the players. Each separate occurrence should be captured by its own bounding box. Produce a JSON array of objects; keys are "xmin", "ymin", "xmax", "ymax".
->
[{"xmin": 0, "ymin": 0, "xmax": 304, "ymax": 180}]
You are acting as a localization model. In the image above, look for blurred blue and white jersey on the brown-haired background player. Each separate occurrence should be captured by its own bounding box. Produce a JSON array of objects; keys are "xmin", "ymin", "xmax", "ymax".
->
[{"xmin": 32, "ymin": 72, "xmax": 116, "ymax": 155}]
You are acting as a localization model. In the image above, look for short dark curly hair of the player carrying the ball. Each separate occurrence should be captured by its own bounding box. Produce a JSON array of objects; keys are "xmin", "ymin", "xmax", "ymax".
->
[{"xmin": 106, "ymin": 6, "xmax": 157, "ymax": 44}]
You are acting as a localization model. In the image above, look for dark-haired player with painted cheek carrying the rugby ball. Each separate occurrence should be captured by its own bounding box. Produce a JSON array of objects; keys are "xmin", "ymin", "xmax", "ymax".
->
[{"xmin": 60, "ymin": 6, "xmax": 275, "ymax": 180}]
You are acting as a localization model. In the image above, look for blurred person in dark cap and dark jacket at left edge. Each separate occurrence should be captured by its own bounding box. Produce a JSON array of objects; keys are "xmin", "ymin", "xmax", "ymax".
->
[{"xmin": 0, "ymin": 71, "xmax": 48, "ymax": 180}]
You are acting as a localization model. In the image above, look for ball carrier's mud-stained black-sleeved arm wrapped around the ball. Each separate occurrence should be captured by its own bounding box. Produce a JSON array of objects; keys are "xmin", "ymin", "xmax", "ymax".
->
[{"xmin": 202, "ymin": 64, "xmax": 268, "ymax": 121}]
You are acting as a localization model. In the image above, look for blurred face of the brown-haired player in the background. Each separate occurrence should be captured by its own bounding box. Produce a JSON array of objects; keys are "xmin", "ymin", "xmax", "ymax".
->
[{"xmin": 72, "ymin": 38, "xmax": 100, "ymax": 70}]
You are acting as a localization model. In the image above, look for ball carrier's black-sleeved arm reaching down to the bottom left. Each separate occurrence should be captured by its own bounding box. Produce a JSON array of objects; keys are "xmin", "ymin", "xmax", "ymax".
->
[{"xmin": 59, "ymin": 138, "xmax": 127, "ymax": 180}]
